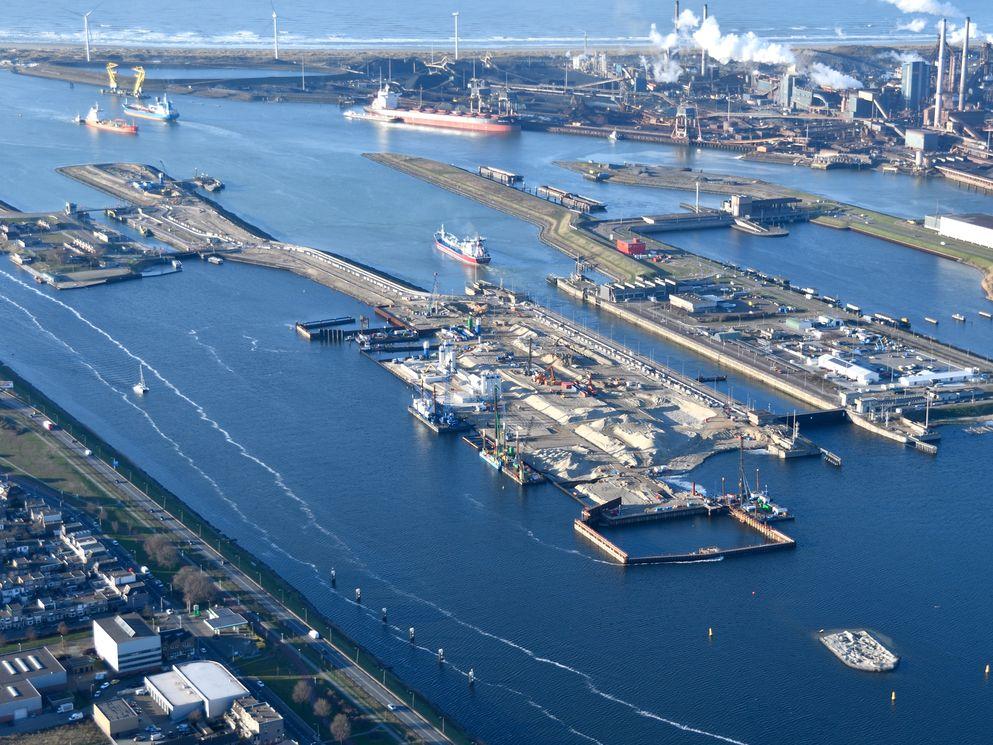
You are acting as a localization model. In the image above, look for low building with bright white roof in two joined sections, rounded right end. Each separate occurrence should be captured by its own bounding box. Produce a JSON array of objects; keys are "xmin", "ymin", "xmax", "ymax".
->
[{"xmin": 145, "ymin": 660, "xmax": 248, "ymax": 722}]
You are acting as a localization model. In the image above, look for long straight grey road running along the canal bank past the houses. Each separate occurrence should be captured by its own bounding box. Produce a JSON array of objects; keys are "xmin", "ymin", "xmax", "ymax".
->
[{"xmin": 0, "ymin": 392, "xmax": 451, "ymax": 743}]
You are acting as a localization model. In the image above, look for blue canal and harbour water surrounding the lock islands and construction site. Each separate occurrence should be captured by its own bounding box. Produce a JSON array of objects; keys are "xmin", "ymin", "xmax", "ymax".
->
[{"xmin": 0, "ymin": 70, "xmax": 993, "ymax": 744}]
